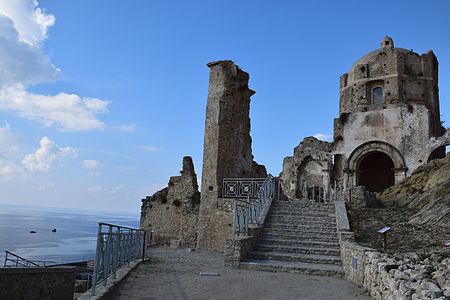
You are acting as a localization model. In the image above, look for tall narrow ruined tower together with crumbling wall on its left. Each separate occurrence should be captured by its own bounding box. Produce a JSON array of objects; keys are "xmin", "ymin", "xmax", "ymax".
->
[{"xmin": 141, "ymin": 60, "xmax": 267, "ymax": 251}]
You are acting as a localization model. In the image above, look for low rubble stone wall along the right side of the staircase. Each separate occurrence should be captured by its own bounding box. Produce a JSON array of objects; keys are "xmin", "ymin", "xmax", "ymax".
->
[{"xmin": 335, "ymin": 201, "xmax": 450, "ymax": 300}]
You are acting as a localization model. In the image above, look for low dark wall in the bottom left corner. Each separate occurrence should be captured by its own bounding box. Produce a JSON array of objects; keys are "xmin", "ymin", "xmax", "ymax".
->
[{"xmin": 0, "ymin": 267, "xmax": 75, "ymax": 300}]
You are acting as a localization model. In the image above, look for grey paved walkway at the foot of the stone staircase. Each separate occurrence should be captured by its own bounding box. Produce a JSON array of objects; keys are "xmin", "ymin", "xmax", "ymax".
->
[{"xmin": 108, "ymin": 247, "xmax": 370, "ymax": 300}]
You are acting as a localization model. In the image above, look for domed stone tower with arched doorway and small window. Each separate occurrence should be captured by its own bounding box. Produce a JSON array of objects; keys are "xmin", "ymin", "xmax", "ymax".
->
[{"xmin": 334, "ymin": 36, "xmax": 444, "ymax": 192}]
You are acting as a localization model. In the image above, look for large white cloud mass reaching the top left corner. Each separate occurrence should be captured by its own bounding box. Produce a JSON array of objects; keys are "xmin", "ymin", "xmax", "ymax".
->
[{"xmin": 0, "ymin": 0, "xmax": 109, "ymax": 131}]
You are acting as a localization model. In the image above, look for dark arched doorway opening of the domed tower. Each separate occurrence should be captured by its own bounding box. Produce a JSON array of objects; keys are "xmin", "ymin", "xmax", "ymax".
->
[{"xmin": 357, "ymin": 151, "xmax": 395, "ymax": 192}]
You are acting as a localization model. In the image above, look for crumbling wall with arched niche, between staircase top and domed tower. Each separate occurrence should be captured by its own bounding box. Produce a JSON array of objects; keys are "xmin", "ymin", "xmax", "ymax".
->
[{"xmin": 280, "ymin": 137, "xmax": 333, "ymax": 199}]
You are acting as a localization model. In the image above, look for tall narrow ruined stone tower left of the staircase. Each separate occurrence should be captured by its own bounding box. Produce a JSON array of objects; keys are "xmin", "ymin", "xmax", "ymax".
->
[{"xmin": 198, "ymin": 60, "xmax": 266, "ymax": 251}]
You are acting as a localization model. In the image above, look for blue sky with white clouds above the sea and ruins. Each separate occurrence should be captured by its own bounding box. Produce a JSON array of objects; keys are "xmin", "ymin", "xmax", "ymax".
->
[{"xmin": 0, "ymin": 0, "xmax": 450, "ymax": 214}]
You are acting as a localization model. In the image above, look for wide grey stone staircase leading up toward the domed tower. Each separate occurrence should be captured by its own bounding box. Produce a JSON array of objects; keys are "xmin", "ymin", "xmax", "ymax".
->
[{"xmin": 239, "ymin": 200, "xmax": 344, "ymax": 277}]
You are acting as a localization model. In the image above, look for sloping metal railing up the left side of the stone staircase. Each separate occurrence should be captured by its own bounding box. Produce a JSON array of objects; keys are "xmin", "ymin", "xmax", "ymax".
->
[{"xmin": 232, "ymin": 174, "xmax": 275, "ymax": 240}]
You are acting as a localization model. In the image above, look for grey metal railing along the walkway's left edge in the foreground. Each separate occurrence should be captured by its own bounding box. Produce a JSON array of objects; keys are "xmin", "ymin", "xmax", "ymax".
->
[{"xmin": 92, "ymin": 223, "xmax": 145, "ymax": 295}]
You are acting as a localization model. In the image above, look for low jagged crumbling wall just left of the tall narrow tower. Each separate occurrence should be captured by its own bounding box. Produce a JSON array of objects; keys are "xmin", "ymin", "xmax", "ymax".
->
[{"xmin": 140, "ymin": 156, "xmax": 200, "ymax": 247}]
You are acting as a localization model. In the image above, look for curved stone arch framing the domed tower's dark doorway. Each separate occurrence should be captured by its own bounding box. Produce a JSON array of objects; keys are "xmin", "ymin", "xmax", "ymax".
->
[{"xmin": 347, "ymin": 141, "xmax": 407, "ymax": 186}]
